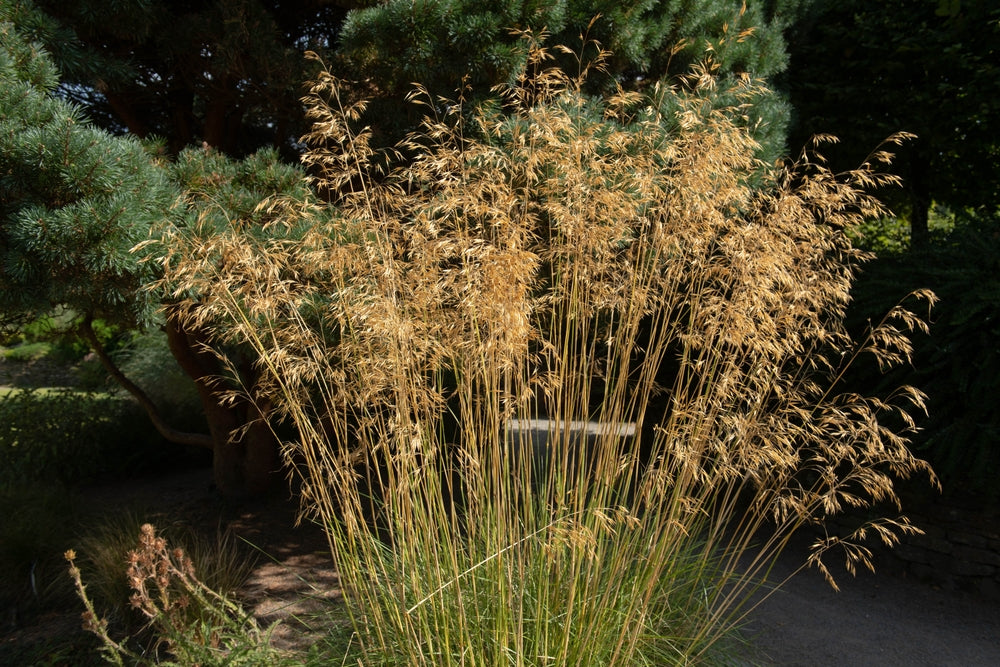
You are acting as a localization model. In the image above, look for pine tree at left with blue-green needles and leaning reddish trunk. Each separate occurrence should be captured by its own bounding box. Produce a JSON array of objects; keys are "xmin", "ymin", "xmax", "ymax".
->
[{"xmin": 0, "ymin": 18, "xmax": 308, "ymax": 496}]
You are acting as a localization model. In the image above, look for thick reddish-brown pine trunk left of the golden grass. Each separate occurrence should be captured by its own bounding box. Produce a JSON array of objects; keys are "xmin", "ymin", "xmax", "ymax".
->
[{"xmin": 166, "ymin": 317, "xmax": 281, "ymax": 497}]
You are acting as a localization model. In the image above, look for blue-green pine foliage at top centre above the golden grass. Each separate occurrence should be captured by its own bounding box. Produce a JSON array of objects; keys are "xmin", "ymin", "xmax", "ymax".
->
[{"xmin": 340, "ymin": 0, "xmax": 799, "ymax": 160}]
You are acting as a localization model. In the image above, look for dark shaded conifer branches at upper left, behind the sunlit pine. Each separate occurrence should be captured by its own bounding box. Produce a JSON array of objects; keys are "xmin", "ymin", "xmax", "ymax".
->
[{"xmin": 4, "ymin": 0, "xmax": 354, "ymax": 157}]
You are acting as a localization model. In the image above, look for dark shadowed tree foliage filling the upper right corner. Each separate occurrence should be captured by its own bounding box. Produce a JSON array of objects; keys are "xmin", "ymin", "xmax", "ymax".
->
[{"xmin": 783, "ymin": 0, "xmax": 1000, "ymax": 247}]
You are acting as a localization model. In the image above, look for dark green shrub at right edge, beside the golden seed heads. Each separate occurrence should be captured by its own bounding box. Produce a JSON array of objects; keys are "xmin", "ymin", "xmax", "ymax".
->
[{"xmin": 853, "ymin": 212, "xmax": 1000, "ymax": 503}]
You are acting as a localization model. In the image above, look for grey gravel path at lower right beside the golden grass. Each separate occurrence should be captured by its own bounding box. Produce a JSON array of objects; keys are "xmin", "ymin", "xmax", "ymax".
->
[{"xmin": 746, "ymin": 536, "xmax": 1000, "ymax": 667}]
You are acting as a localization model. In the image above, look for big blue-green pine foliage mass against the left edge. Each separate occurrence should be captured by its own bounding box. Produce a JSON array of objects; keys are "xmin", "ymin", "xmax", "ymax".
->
[{"xmin": 0, "ymin": 18, "xmax": 179, "ymax": 324}]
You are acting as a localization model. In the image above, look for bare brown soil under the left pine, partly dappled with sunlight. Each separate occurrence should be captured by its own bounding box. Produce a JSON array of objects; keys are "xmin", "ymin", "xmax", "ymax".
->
[{"xmin": 0, "ymin": 469, "xmax": 340, "ymax": 667}]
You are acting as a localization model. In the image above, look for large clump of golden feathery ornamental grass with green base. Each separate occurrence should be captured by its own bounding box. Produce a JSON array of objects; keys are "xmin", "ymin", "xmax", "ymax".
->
[{"xmin": 148, "ymin": 43, "xmax": 930, "ymax": 665}]
